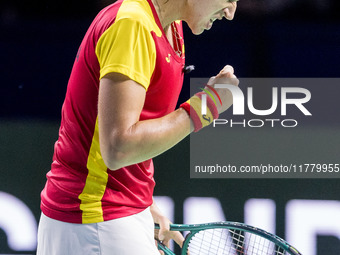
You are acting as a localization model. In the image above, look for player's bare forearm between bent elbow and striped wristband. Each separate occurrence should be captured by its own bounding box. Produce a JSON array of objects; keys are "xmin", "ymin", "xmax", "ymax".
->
[{"xmin": 102, "ymin": 108, "xmax": 193, "ymax": 170}]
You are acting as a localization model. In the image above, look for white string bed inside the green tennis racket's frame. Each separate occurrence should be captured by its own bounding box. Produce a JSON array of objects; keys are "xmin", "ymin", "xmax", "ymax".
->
[{"xmin": 188, "ymin": 228, "xmax": 288, "ymax": 255}]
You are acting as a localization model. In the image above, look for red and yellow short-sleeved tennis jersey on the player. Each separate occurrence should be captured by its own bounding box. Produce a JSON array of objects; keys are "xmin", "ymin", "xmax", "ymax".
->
[{"xmin": 41, "ymin": 0, "xmax": 184, "ymax": 223}]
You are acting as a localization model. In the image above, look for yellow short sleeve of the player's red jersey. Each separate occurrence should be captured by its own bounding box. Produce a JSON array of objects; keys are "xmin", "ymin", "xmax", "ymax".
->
[{"xmin": 96, "ymin": 19, "xmax": 156, "ymax": 89}]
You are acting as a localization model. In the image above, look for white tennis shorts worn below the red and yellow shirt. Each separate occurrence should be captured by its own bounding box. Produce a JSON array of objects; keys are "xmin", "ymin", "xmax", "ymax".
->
[{"xmin": 37, "ymin": 208, "xmax": 159, "ymax": 255}]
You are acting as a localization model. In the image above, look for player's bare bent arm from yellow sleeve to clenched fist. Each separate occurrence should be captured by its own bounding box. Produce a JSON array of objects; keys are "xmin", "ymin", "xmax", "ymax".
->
[{"xmin": 98, "ymin": 66, "xmax": 238, "ymax": 170}]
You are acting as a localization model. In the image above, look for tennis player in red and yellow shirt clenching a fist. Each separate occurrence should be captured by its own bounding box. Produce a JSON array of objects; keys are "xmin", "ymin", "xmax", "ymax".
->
[{"xmin": 37, "ymin": 0, "xmax": 238, "ymax": 255}]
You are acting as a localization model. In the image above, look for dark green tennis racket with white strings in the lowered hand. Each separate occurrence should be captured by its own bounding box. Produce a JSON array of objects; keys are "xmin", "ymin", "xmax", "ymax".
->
[{"xmin": 155, "ymin": 221, "xmax": 302, "ymax": 255}]
